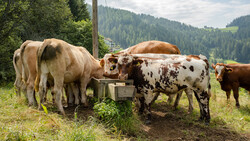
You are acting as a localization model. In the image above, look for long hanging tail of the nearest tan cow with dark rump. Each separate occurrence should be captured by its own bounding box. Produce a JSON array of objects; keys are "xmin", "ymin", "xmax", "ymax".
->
[{"xmin": 35, "ymin": 40, "xmax": 48, "ymax": 92}]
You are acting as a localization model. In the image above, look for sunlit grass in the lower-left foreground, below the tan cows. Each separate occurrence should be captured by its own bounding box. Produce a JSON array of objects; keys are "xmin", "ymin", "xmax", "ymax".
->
[{"xmin": 0, "ymin": 88, "xmax": 117, "ymax": 141}]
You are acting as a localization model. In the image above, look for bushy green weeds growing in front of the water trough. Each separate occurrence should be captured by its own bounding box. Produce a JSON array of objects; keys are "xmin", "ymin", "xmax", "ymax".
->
[{"xmin": 94, "ymin": 98, "xmax": 141, "ymax": 135}]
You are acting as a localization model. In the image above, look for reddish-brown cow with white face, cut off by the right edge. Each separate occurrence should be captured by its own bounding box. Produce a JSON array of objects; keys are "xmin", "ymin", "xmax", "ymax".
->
[{"xmin": 212, "ymin": 63, "xmax": 250, "ymax": 108}]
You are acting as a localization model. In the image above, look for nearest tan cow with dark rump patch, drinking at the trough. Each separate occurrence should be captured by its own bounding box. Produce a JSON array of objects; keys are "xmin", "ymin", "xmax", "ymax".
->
[{"xmin": 35, "ymin": 38, "xmax": 103, "ymax": 116}]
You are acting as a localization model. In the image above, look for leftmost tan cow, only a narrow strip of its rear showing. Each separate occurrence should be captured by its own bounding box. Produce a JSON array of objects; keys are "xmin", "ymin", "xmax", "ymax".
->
[{"xmin": 13, "ymin": 48, "xmax": 26, "ymax": 97}]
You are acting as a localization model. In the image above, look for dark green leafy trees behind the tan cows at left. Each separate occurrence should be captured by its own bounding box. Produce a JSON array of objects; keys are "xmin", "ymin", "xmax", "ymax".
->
[{"xmin": 0, "ymin": 0, "xmax": 109, "ymax": 84}]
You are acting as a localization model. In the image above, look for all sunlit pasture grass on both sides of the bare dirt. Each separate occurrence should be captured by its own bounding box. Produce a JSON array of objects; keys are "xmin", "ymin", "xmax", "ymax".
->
[{"xmin": 0, "ymin": 74, "xmax": 250, "ymax": 141}]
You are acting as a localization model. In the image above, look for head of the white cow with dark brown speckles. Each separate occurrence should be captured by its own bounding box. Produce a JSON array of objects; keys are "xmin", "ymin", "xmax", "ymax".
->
[{"xmin": 118, "ymin": 54, "xmax": 143, "ymax": 80}]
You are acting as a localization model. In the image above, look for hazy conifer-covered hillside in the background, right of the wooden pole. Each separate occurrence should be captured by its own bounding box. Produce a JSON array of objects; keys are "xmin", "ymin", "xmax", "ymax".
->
[{"xmin": 89, "ymin": 6, "xmax": 250, "ymax": 63}]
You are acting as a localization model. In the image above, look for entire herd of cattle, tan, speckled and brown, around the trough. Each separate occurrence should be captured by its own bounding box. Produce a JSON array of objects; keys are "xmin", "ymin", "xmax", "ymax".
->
[{"xmin": 13, "ymin": 38, "xmax": 250, "ymax": 124}]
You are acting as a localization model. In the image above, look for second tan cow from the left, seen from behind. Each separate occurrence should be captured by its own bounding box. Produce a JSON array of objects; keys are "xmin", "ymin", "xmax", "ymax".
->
[{"xmin": 20, "ymin": 40, "xmax": 43, "ymax": 106}]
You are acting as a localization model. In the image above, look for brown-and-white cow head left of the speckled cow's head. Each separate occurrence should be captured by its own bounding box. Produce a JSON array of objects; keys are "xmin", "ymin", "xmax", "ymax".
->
[{"xmin": 101, "ymin": 54, "xmax": 118, "ymax": 79}]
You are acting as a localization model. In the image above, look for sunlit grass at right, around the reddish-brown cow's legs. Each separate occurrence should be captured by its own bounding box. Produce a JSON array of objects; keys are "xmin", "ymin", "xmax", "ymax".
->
[{"xmin": 156, "ymin": 74, "xmax": 250, "ymax": 134}]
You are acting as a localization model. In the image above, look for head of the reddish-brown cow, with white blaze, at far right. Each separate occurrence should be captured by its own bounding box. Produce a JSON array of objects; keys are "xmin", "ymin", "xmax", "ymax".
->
[{"xmin": 212, "ymin": 63, "xmax": 232, "ymax": 82}]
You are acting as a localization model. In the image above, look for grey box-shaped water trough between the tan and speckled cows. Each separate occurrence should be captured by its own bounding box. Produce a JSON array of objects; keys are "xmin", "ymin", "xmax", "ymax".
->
[{"xmin": 91, "ymin": 78, "xmax": 135, "ymax": 101}]
